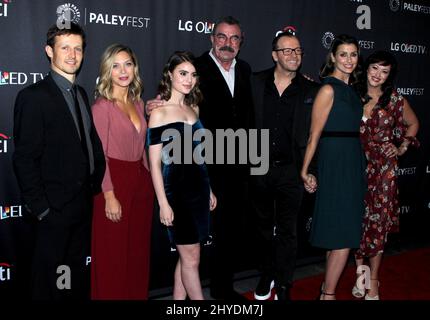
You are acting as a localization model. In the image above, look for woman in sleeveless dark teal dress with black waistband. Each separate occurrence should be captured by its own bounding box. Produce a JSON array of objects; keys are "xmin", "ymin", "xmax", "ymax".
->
[{"xmin": 301, "ymin": 35, "xmax": 366, "ymax": 300}]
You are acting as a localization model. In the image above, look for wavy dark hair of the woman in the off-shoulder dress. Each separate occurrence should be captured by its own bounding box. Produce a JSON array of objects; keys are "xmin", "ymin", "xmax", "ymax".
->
[{"xmin": 158, "ymin": 51, "xmax": 203, "ymax": 106}]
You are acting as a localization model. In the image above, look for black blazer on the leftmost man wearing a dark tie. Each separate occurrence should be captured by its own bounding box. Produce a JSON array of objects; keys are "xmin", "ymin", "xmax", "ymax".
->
[{"xmin": 13, "ymin": 75, "xmax": 105, "ymax": 215}]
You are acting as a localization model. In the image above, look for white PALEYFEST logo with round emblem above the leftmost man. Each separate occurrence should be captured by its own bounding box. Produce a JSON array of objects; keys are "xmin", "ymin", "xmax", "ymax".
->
[{"xmin": 57, "ymin": 3, "xmax": 151, "ymax": 29}]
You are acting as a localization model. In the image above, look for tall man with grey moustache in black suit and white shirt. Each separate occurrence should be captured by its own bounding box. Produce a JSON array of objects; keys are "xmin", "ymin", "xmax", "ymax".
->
[{"xmin": 196, "ymin": 16, "xmax": 253, "ymax": 300}]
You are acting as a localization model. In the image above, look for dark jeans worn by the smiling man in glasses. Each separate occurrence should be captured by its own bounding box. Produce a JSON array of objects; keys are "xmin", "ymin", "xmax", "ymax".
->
[{"xmin": 250, "ymin": 164, "xmax": 303, "ymax": 286}]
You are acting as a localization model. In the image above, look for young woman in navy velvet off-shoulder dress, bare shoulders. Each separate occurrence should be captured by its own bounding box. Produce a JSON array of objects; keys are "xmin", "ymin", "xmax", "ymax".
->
[{"xmin": 147, "ymin": 52, "xmax": 216, "ymax": 300}]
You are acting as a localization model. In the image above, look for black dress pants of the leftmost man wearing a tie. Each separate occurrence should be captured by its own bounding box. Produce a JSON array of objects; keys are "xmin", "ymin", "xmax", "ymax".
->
[{"xmin": 32, "ymin": 186, "xmax": 92, "ymax": 300}]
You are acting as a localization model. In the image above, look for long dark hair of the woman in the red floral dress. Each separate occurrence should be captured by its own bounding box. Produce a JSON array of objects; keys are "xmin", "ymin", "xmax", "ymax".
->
[{"xmin": 356, "ymin": 51, "xmax": 397, "ymax": 108}]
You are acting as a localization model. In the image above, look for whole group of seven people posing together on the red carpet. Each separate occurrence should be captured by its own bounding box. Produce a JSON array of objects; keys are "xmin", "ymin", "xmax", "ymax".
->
[{"xmin": 13, "ymin": 16, "xmax": 418, "ymax": 300}]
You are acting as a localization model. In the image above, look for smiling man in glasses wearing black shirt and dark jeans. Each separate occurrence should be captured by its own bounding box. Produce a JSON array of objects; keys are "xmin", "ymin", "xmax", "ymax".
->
[{"xmin": 251, "ymin": 28, "xmax": 319, "ymax": 300}]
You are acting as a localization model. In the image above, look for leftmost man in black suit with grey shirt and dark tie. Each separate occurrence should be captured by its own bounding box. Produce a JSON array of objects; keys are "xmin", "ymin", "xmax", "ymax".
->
[{"xmin": 13, "ymin": 23, "xmax": 105, "ymax": 300}]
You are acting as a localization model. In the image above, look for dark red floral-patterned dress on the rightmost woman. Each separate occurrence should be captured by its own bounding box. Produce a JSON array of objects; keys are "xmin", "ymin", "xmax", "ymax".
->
[{"xmin": 356, "ymin": 91, "xmax": 418, "ymax": 259}]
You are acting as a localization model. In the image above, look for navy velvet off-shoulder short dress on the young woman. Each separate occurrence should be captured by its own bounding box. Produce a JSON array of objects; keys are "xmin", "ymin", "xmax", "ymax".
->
[{"xmin": 146, "ymin": 120, "xmax": 210, "ymax": 244}]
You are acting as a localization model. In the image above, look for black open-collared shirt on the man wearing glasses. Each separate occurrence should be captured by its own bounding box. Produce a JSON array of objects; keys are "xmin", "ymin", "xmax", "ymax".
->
[{"xmin": 263, "ymin": 73, "xmax": 298, "ymax": 163}]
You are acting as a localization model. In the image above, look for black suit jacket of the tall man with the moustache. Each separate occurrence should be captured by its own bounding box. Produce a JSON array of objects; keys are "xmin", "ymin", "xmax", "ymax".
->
[{"xmin": 196, "ymin": 51, "xmax": 254, "ymax": 184}]
